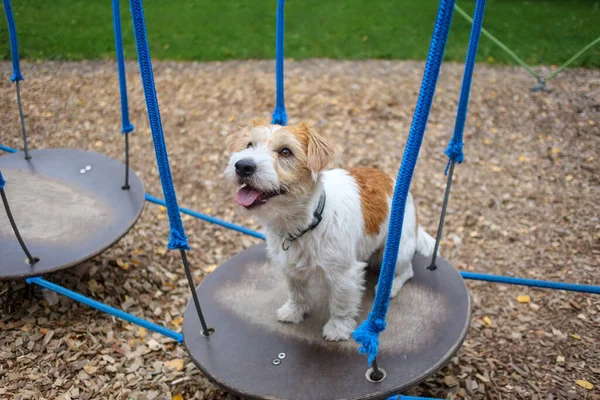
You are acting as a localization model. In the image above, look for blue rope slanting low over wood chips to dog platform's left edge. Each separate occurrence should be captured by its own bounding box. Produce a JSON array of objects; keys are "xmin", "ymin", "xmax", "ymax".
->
[{"xmin": 26, "ymin": 277, "xmax": 183, "ymax": 343}]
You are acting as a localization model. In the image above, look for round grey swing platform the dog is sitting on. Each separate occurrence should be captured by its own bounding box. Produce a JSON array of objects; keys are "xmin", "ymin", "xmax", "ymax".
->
[{"xmin": 183, "ymin": 245, "xmax": 471, "ymax": 400}]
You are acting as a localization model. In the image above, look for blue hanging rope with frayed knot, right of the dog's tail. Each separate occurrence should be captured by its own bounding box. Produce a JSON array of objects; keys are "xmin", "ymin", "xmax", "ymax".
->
[{"xmin": 444, "ymin": 0, "xmax": 485, "ymax": 175}]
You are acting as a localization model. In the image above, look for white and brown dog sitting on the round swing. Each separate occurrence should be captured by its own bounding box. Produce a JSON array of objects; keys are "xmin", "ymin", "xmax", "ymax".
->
[{"xmin": 225, "ymin": 120, "xmax": 434, "ymax": 340}]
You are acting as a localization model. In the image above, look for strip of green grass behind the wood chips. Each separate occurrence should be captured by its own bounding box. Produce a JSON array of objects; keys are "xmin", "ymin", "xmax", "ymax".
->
[{"xmin": 0, "ymin": 0, "xmax": 600, "ymax": 68}]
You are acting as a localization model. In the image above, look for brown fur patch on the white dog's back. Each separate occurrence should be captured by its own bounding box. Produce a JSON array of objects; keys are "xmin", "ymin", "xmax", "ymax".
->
[{"xmin": 349, "ymin": 168, "xmax": 394, "ymax": 235}]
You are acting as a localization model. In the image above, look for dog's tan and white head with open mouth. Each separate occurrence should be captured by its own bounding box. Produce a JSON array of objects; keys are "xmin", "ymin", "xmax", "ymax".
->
[{"xmin": 225, "ymin": 120, "xmax": 339, "ymax": 214}]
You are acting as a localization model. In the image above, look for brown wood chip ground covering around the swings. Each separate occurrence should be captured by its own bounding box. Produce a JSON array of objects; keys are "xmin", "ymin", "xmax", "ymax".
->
[{"xmin": 0, "ymin": 59, "xmax": 600, "ymax": 400}]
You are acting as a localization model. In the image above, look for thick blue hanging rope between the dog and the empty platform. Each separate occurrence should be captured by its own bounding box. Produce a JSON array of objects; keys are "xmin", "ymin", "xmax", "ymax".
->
[{"xmin": 130, "ymin": 0, "xmax": 190, "ymax": 250}]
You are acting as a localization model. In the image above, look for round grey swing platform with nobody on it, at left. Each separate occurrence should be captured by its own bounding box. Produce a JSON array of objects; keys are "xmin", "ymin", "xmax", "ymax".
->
[{"xmin": 0, "ymin": 149, "xmax": 145, "ymax": 280}]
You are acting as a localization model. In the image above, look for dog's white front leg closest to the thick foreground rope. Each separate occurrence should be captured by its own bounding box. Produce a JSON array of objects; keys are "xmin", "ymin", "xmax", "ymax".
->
[{"xmin": 323, "ymin": 260, "xmax": 367, "ymax": 341}]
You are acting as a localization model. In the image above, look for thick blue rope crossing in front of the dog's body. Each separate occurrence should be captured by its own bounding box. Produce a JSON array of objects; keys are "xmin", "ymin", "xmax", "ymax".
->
[{"xmin": 353, "ymin": 0, "xmax": 455, "ymax": 364}]
